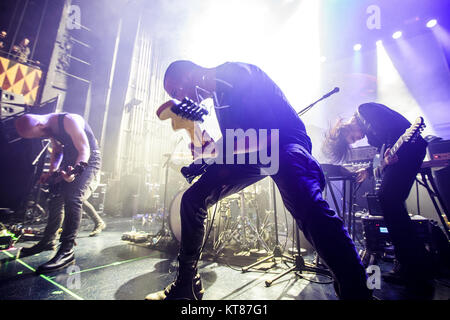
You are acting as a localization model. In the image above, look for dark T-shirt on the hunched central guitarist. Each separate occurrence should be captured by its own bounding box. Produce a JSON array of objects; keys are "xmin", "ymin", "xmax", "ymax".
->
[{"xmin": 215, "ymin": 62, "xmax": 311, "ymax": 152}]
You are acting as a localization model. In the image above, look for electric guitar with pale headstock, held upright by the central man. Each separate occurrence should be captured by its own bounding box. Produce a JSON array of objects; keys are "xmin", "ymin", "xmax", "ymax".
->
[{"xmin": 156, "ymin": 98, "xmax": 214, "ymax": 183}]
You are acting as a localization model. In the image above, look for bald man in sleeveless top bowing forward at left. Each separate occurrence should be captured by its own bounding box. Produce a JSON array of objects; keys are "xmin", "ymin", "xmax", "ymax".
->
[{"xmin": 15, "ymin": 113, "xmax": 101, "ymax": 273}]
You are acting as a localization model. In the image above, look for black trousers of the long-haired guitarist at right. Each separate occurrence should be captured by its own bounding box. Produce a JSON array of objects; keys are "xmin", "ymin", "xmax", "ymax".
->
[{"xmin": 378, "ymin": 139, "xmax": 431, "ymax": 280}]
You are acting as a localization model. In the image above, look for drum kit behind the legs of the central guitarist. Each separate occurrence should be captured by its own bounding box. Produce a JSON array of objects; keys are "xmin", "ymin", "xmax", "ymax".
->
[{"xmin": 134, "ymin": 150, "xmax": 276, "ymax": 256}]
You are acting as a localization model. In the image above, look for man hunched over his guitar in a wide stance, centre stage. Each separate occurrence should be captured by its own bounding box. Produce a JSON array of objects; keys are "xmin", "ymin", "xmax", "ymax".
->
[{"xmin": 146, "ymin": 60, "xmax": 371, "ymax": 300}]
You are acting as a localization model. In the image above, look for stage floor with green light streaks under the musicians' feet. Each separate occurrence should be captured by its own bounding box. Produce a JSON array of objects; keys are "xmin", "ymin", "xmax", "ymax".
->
[{"xmin": 0, "ymin": 217, "xmax": 450, "ymax": 300}]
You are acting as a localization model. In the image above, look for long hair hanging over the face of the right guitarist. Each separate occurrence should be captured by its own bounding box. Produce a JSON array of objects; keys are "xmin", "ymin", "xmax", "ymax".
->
[{"xmin": 322, "ymin": 118, "xmax": 350, "ymax": 163}]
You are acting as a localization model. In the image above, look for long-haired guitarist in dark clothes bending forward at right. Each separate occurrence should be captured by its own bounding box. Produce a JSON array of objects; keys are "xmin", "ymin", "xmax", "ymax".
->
[{"xmin": 323, "ymin": 102, "xmax": 432, "ymax": 294}]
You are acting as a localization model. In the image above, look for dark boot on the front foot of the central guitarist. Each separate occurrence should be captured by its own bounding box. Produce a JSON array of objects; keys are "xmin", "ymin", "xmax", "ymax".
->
[{"xmin": 145, "ymin": 262, "xmax": 205, "ymax": 300}]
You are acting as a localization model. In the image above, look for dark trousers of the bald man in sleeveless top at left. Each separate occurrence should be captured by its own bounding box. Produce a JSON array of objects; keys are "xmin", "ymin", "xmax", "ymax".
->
[{"xmin": 43, "ymin": 153, "xmax": 101, "ymax": 243}]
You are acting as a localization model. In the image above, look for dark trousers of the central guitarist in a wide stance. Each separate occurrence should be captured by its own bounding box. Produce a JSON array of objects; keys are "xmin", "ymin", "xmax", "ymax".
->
[{"xmin": 180, "ymin": 144, "xmax": 369, "ymax": 299}]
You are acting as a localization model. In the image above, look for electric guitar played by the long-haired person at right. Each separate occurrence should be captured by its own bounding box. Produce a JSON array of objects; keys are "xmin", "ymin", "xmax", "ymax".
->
[{"xmin": 373, "ymin": 117, "xmax": 426, "ymax": 191}]
